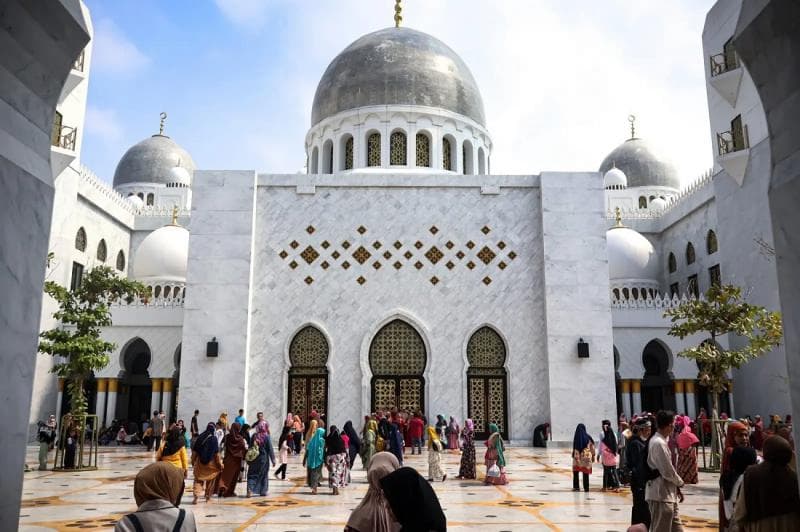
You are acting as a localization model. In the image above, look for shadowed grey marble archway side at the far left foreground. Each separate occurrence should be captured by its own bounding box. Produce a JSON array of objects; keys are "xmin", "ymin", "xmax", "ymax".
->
[{"xmin": 0, "ymin": 0, "xmax": 89, "ymax": 531}]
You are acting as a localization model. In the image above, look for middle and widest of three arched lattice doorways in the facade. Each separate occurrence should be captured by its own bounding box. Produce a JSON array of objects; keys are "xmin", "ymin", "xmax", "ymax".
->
[{"xmin": 369, "ymin": 319, "xmax": 428, "ymax": 413}]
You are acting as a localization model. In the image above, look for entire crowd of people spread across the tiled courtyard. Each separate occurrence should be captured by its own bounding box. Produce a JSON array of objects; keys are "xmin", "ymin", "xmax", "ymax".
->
[{"xmin": 39, "ymin": 409, "xmax": 800, "ymax": 532}]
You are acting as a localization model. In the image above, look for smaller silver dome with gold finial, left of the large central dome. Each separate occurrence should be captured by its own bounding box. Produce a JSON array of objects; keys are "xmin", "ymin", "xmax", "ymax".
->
[{"xmin": 114, "ymin": 135, "xmax": 195, "ymax": 187}]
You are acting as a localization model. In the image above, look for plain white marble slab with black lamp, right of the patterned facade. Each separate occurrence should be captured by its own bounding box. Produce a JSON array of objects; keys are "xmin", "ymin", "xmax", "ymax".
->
[{"xmin": 541, "ymin": 172, "xmax": 616, "ymax": 442}]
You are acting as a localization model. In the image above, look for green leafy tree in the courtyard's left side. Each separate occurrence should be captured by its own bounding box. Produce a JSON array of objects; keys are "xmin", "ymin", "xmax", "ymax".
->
[{"xmin": 39, "ymin": 266, "xmax": 150, "ymax": 419}]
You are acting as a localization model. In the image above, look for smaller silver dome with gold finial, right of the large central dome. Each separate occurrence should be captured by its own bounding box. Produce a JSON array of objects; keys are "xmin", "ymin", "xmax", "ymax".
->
[{"xmin": 600, "ymin": 138, "xmax": 681, "ymax": 190}]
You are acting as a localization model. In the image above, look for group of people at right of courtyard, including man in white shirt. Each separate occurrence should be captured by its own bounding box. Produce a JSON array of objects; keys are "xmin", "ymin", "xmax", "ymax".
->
[{"xmin": 572, "ymin": 409, "xmax": 800, "ymax": 532}]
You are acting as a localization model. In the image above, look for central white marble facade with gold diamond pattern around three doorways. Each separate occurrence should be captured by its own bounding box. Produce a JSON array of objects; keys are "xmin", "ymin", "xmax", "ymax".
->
[{"xmin": 248, "ymin": 175, "xmax": 548, "ymax": 441}]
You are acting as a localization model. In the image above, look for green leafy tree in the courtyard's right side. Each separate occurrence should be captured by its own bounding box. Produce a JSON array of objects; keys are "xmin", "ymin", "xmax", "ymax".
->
[{"xmin": 664, "ymin": 284, "xmax": 783, "ymax": 466}]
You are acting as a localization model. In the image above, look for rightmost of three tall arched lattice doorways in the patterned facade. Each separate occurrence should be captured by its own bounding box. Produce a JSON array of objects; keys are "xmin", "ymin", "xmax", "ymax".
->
[{"xmin": 467, "ymin": 327, "xmax": 508, "ymax": 440}]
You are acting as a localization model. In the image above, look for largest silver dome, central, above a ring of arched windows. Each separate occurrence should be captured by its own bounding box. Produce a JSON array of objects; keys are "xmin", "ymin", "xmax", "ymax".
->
[{"xmin": 311, "ymin": 27, "xmax": 486, "ymax": 126}]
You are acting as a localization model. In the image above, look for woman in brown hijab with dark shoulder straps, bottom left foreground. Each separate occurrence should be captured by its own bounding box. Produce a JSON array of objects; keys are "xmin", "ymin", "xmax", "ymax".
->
[{"xmin": 114, "ymin": 462, "xmax": 197, "ymax": 532}]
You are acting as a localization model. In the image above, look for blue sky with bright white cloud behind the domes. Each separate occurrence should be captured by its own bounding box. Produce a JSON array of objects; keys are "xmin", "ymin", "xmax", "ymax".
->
[{"xmin": 82, "ymin": 0, "xmax": 713, "ymax": 186}]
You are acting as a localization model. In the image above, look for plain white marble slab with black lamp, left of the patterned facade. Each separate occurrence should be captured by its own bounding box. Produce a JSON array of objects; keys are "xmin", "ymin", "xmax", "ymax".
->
[{"xmin": 178, "ymin": 171, "xmax": 258, "ymax": 419}]
